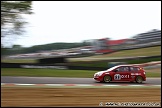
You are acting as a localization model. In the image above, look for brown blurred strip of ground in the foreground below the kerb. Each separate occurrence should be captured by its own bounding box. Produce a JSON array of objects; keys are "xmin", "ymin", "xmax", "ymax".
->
[{"xmin": 1, "ymin": 87, "xmax": 161, "ymax": 107}]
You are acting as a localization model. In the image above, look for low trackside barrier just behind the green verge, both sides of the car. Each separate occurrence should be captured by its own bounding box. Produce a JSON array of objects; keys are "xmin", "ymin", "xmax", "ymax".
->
[{"xmin": 1, "ymin": 61, "xmax": 161, "ymax": 71}]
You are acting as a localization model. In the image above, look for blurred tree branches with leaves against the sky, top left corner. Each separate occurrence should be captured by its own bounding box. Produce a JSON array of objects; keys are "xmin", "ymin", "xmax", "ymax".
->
[{"xmin": 1, "ymin": 1, "xmax": 32, "ymax": 46}]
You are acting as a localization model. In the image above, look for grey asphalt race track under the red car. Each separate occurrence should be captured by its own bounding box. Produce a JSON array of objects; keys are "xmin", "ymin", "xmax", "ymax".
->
[{"xmin": 1, "ymin": 76, "xmax": 161, "ymax": 85}]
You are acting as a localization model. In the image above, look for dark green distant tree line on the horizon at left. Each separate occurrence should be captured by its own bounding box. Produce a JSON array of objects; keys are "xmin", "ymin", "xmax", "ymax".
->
[{"xmin": 1, "ymin": 42, "xmax": 90, "ymax": 55}]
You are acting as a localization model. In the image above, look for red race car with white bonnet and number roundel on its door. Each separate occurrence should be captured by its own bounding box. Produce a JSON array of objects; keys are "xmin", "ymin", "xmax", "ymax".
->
[{"xmin": 94, "ymin": 65, "xmax": 146, "ymax": 83}]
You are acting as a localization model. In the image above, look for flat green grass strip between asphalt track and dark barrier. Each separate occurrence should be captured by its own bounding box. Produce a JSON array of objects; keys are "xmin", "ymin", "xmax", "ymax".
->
[{"xmin": 1, "ymin": 68, "xmax": 161, "ymax": 78}]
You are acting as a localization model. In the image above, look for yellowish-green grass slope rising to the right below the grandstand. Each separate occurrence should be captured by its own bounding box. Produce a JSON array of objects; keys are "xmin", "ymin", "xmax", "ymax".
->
[{"xmin": 69, "ymin": 46, "xmax": 161, "ymax": 62}]
